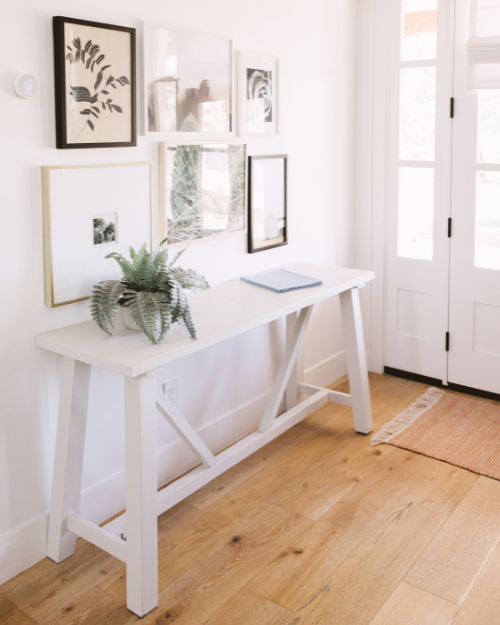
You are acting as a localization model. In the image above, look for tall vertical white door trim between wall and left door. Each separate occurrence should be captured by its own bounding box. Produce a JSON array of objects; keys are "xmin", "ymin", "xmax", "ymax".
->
[{"xmin": 355, "ymin": 0, "xmax": 389, "ymax": 373}]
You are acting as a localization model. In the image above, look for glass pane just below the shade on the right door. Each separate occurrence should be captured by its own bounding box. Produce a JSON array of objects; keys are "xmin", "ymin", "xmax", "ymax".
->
[{"xmin": 477, "ymin": 89, "xmax": 500, "ymax": 163}]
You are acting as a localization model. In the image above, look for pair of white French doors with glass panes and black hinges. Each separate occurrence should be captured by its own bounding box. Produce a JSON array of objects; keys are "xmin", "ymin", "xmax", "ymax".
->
[{"xmin": 385, "ymin": 0, "xmax": 500, "ymax": 394}]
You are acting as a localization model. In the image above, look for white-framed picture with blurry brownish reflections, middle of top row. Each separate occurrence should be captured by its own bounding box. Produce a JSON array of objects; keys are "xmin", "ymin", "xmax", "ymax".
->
[{"xmin": 143, "ymin": 22, "xmax": 234, "ymax": 141}]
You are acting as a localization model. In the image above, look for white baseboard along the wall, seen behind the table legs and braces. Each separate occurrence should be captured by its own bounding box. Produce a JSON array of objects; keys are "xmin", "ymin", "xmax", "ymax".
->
[{"xmin": 0, "ymin": 350, "xmax": 347, "ymax": 584}]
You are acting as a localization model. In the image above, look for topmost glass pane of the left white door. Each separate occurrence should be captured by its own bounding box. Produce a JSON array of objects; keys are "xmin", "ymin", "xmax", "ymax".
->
[{"xmin": 401, "ymin": 0, "xmax": 437, "ymax": 61}]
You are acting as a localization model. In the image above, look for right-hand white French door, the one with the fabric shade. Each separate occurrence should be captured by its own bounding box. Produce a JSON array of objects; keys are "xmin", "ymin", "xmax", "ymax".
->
[{"xmin": 448, "ymin": 0, "xmax": 500, "ymax": 393}]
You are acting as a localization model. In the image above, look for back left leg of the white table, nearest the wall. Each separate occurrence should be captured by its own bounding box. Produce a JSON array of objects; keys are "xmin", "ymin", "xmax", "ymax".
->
[{"xmin": 47, "ymin": 356, "xmax": 90, "ymax": 562}]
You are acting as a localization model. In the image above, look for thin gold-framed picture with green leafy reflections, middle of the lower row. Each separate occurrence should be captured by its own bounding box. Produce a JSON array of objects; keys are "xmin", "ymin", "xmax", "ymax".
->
[{"xmin": 160, "ymin": 142, "xmax": 247, "ymax": 245}]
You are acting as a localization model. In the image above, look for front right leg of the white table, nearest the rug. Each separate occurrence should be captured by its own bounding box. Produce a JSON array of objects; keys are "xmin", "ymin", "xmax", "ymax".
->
[{"xmin": 340, "ymin": 288, "xmax": 373, "ymax": 434}]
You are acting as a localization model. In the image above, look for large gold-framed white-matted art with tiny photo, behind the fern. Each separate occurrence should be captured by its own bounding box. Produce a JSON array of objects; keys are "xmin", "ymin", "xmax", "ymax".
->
[{"xmin": 42, "ymin": 163, "xmax": 152, "ymax": 308}]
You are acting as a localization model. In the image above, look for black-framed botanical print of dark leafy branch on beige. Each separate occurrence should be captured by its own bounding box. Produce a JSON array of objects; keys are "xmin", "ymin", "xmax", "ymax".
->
[{"xmin": 53, "ymin": 16, "xmax": 137, "ymax": 149}]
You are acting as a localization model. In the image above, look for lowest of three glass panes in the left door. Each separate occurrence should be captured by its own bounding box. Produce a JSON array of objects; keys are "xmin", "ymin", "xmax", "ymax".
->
[{"xmin": 398, "ymin": 167, "xmax": 434, "ymax": 260}]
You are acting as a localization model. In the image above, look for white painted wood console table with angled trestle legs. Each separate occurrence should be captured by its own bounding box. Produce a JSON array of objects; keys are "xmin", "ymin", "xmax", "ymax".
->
[{"xmin": 36, "ymin": 264, "xmax": 375, "ymax": 616}]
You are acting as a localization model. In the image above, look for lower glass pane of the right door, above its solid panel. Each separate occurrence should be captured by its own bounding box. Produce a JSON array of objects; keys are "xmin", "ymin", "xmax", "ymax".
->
[{"xmin": 474, "ymin": 171, "xmax": 500, "ymax": 271}]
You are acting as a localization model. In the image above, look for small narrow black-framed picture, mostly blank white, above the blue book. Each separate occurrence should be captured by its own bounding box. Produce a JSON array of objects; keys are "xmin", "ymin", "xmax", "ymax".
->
[{"xmin": 248, "ymin": 155, "xmax": 288, "ymax": 254}]
